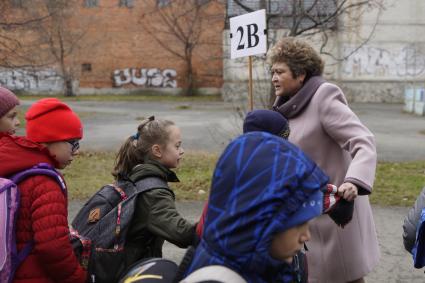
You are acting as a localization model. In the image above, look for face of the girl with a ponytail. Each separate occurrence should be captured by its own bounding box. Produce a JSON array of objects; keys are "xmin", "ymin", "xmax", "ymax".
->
[{"xmin": 153, "ymin": 126, "xmax": 184, "ymax": 168}]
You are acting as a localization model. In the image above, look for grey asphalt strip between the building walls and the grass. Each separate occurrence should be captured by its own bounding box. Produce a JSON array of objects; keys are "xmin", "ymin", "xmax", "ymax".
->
[{"xmin": 19, "ymin": 101, "xmax": 425, "ymax": 161}]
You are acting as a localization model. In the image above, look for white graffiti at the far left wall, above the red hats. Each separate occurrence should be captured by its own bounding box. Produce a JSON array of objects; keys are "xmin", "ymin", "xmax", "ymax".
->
[{"xmin": 0, "ymin": 69, "xmax": 63, "ymax": 91}]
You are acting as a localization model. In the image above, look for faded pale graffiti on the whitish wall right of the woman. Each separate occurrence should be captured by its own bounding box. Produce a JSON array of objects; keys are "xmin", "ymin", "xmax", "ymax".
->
[{"xmin": 342, "ymin": 44, "xmax": 425, "ymax": 78}]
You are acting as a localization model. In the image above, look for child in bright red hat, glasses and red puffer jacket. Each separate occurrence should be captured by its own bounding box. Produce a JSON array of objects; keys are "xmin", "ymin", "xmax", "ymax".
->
[{"xmin": 0, "ymin": 98, "xmax": 86, "ymax": 282}]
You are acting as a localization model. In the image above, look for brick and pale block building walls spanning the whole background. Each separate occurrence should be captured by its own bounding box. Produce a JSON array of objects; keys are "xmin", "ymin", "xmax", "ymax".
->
[{"xmin": 0, "ymin": 0, "xmax": 425, "ymax": 102}]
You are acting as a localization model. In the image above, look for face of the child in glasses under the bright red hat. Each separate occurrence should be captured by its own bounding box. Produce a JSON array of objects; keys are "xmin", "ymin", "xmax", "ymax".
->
[{"xmin": 45, "ymin": 140, "xmax": 79, "ymax": 169}]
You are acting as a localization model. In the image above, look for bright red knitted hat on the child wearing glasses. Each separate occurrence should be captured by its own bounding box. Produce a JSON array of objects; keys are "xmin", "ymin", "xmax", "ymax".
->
[{"xmin": 25, "ymin": 98, "xmax": 83, "ymax": 142}]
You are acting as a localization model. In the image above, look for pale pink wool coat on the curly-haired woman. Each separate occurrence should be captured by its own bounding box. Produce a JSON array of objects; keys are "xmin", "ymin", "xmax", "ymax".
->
[{"xmin": 289, "ymin": 83, "xmax": 379, "ymax": 283}]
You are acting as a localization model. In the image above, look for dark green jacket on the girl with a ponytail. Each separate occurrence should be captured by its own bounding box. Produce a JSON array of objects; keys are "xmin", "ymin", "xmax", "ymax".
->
[{"xmin": 125, "ymin": 160, "xmax": 196, "ymax": 266}]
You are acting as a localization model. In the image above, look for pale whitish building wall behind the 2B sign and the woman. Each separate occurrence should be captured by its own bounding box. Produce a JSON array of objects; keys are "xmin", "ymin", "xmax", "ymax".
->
[{"xmin": 223, "ymin": 0, "xmax": 425, "ymax": 104}]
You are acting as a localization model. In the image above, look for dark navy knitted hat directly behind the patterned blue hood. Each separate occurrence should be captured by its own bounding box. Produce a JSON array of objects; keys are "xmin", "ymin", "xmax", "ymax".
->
[{"xmin": 243, "ymin": 109, "xmax": 289, "ymax": 139}]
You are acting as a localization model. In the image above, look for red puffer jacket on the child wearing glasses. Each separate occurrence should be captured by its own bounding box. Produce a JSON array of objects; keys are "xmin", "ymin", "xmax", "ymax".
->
[{"xmin": 0, "ymin": 134, "xmax": 86, "ymax": 283}]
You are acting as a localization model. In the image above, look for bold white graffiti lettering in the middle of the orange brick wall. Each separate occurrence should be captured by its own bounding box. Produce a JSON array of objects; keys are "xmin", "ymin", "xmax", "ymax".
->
[{"xmin": 114, "ymin": 68, "xmax": 177, "ymax": 88}]
